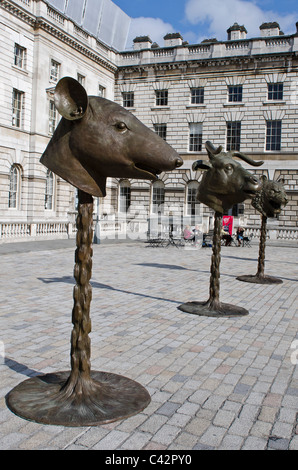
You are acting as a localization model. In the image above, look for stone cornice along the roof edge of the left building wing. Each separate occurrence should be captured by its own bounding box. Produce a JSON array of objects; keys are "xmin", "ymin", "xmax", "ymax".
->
[{"xmin": 0, "ymin": 0, "xmax": 117, "ymax": 73}]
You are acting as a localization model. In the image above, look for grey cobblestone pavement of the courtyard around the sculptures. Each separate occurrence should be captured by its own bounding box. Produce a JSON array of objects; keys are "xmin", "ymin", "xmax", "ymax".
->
[{"xmin": 0, "ymin": 241, "xmax": 298, "ymax": 451}]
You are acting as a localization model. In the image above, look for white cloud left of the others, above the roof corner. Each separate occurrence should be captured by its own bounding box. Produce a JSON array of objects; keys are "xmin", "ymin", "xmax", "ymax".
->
[{"xmin": 126, "ymin": 17, "xmax": 176, "ymax": 49}]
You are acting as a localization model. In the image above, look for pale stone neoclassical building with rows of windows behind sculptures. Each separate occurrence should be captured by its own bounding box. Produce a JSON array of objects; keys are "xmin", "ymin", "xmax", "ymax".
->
[{"xmin": 0, "ymin": 0, "xmax": 298, "ymax": 243}]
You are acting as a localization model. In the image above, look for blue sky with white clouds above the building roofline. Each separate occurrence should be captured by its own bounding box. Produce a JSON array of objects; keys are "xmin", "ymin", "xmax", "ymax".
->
[{"xmin": 113, "ymin": 0, "xmax": 298, "ymax": 49}]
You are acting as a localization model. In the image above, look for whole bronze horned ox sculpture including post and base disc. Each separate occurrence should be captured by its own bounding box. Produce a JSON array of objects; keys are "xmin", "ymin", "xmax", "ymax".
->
[{"xmin": 178, "ymin": 142, "xmax": 263, "ymax": 317}]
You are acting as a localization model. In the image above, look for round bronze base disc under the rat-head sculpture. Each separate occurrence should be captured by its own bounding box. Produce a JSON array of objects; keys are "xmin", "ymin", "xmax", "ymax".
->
[{"xmin": 6, "ymin": 372, "xmax": 151, "ymax": 426}]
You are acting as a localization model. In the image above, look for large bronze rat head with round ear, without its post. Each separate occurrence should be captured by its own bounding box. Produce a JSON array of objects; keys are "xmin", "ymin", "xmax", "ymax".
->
[{"xmin": 40, "ymin": 77, "xmax": 183, "ymax": 197}]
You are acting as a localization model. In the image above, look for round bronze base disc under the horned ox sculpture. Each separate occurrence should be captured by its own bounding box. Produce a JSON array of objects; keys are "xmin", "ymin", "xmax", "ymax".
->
[{"xmin": 178, "ymin": 302, "xmax": 249, "ymax": 317}]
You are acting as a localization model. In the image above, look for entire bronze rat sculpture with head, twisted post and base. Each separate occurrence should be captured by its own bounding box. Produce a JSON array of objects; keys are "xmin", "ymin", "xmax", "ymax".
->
[{"xmin": 6, "ymin": 77, "xmax": 183, "ymax": 426}]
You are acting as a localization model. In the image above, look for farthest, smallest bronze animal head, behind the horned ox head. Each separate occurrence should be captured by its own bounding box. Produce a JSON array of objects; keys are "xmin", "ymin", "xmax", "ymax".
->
[{"xmin": 251, "ymin": 175, "xmax": 288, "ymax": 217}]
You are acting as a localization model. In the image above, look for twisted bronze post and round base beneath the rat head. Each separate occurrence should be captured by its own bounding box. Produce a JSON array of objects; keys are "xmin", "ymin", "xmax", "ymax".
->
[{"xmin": 6, "ymin": 191, "xmax": 150, "ymax": 426}]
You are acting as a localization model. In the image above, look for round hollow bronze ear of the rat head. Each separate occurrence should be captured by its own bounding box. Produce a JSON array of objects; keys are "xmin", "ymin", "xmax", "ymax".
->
[{"xmin": 54, "ymin": 77, "xmax": 88, "ymax": 121}]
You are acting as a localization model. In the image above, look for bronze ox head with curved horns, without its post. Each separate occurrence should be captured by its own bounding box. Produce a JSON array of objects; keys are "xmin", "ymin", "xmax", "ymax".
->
[{"xmin": 192, "ymin": 141, "xmax": 263, "ymax": 214}]
